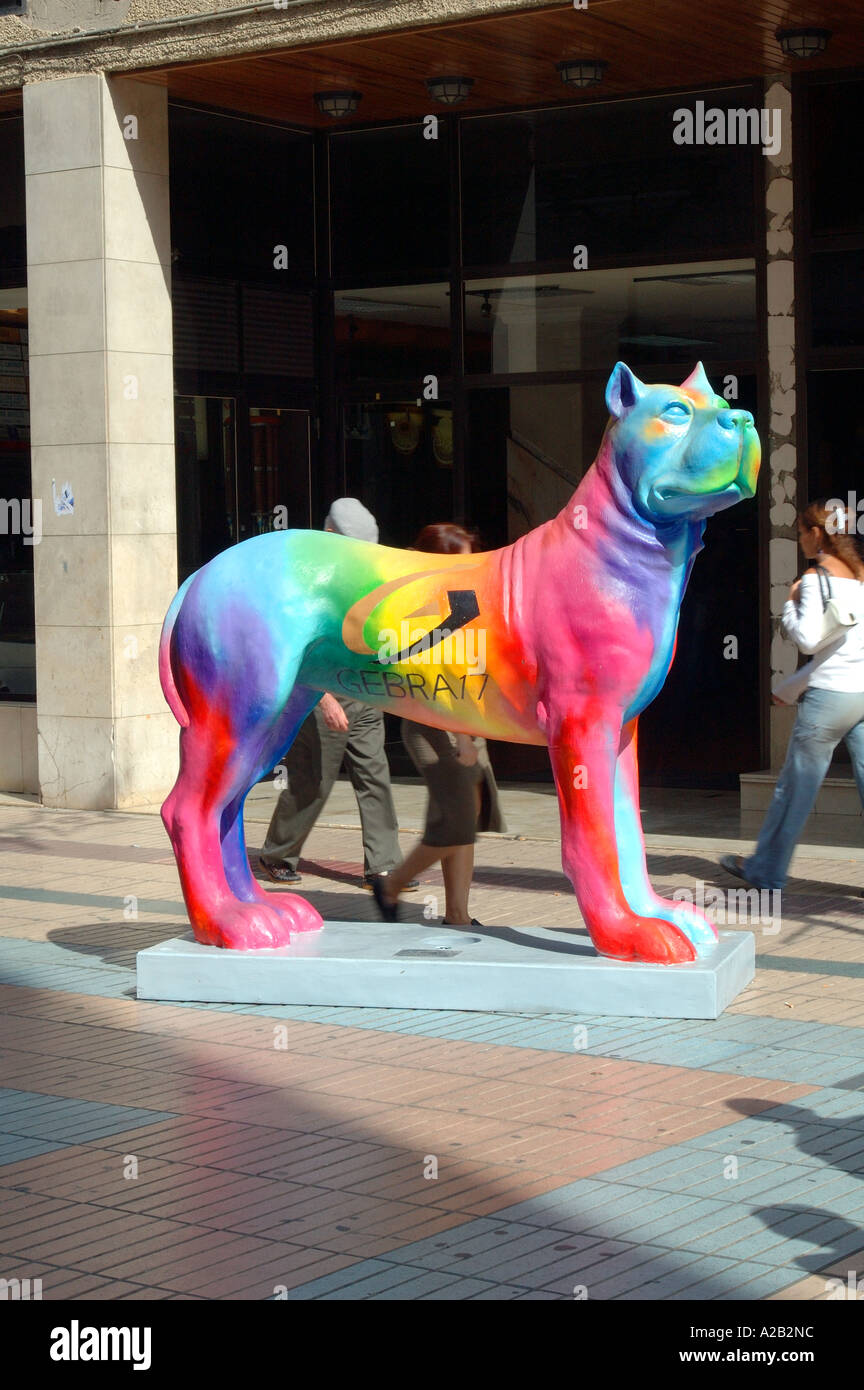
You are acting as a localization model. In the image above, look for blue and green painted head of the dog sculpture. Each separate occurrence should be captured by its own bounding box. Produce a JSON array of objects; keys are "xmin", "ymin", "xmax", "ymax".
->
[{"xmin": 606, "ymin": 361, "xmax": 761, "ymax": 525}]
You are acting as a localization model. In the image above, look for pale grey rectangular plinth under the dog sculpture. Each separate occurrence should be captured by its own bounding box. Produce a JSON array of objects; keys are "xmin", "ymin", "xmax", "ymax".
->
[{"xmin": 138, "ymin": 922, "xmax": 756, "ymax": 1019}]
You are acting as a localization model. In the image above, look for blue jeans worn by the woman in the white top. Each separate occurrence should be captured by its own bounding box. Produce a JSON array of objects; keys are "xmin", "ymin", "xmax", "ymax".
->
[{"xmin": 743, "ymin": 689, "xmax": 864, "ymax": 888}]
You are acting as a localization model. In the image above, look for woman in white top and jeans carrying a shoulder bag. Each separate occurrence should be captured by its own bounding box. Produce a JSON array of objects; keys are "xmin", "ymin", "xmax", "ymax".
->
[{"xmin": 721, "ymin": 502, "xmax": 864, "ymax": 888}]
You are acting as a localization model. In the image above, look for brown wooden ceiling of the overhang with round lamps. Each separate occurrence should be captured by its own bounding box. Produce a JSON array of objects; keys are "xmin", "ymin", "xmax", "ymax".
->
[{"xmin": 131, "ymin": 0, "xmax": 864, "ymax": 128}]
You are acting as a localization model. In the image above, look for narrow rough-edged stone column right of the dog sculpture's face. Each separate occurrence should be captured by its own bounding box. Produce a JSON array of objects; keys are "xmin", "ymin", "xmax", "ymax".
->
[{"xmin": 763, "ymin": 74, "xmax": 797, "ymax": 771}]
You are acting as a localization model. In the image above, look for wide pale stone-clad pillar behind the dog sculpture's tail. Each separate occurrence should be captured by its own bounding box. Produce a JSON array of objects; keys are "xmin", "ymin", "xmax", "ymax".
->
[{"xmin": 24, "ymin": 74, "xmax": 176, "ymax": 809}]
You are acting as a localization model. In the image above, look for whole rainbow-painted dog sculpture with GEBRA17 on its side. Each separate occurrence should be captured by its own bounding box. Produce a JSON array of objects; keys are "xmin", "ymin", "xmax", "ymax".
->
[{"xmin": 160, "ymin": 363, "xmax": 760, "ymax": 965}]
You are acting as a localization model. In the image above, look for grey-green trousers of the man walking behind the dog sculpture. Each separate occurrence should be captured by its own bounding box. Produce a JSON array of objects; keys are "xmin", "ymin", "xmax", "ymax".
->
[{"xmin": 261, "ymin": 698, "xmax": 401, "ymax": 873}]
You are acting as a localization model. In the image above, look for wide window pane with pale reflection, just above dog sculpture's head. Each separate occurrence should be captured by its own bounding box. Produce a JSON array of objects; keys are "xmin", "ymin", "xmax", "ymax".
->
[{"xmin": 465, "ymin": 260, "xmax": 757, "ymax": 374}]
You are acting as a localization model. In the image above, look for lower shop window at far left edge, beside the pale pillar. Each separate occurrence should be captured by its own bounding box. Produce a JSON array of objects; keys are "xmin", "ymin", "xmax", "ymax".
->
[{"xmin": 0, "ymin": 300, "xmax": 34, "ymax": 701}]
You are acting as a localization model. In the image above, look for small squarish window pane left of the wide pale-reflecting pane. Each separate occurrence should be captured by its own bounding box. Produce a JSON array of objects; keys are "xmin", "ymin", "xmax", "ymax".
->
[{"xmin": 335, "ymin": 285, "xmax": 450, "ymax": 383}]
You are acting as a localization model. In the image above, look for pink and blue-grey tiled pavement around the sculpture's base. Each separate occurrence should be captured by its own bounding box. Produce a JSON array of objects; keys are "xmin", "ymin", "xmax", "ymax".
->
[{"xmin": 0, "ymin": 784, "xmax": 864, "ymax": 1300}]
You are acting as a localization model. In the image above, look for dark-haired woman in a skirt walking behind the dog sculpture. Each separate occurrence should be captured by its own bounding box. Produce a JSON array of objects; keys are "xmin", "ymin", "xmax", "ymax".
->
[{"xmin": 375, "ymin": 521, "xmax": 504, "ymax": 927}]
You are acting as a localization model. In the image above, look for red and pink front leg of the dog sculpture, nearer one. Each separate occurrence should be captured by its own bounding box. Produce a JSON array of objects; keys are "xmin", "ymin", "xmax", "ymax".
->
[{"xmin": 546, "ymin": 696, "xmax": 696, "ymax": 965}]
